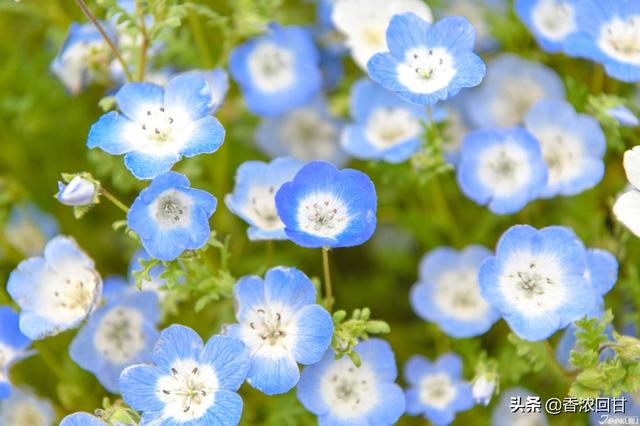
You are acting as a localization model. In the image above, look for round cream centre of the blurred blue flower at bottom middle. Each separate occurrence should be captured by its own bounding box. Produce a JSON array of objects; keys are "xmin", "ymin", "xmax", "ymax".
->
[{"xmin": 320, "ymin": 357, "xmax": 384, "ymax": 419}]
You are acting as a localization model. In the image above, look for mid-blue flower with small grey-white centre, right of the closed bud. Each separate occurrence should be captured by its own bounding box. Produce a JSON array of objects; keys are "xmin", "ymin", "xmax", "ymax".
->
[{"xmin": 127, "ymin": 172, "xmax": 217, "ymax": 261}]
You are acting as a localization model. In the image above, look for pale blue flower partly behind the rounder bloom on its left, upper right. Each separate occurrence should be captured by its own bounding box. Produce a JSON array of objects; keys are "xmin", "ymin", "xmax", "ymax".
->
[{"xmin": 524, "ymin": 100, "xmax": 607, "ymax": 198}]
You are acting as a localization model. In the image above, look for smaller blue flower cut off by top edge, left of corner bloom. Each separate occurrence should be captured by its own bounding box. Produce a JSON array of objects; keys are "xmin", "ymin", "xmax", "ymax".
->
[{"xmin": 515, "ymin": 0, "xmax": 582, "ymax": 52}]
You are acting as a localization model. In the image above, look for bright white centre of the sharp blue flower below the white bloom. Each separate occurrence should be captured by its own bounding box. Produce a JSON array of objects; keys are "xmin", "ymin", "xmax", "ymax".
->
[{"xmin": 396, "ymin": 47, "xmax": 456, "ymax": 94}]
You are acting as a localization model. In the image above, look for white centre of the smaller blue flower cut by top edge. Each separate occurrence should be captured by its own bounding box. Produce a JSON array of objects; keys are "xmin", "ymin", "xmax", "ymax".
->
[{"xmin": 532, "ymin": 0, "xmax": 576, "ymax": 41}]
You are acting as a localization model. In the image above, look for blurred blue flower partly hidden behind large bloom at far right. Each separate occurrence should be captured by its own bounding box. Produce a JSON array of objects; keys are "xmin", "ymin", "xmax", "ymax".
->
[{"xmin": 410, "ymin": 246, "xmax": 500, "ymax": 338}]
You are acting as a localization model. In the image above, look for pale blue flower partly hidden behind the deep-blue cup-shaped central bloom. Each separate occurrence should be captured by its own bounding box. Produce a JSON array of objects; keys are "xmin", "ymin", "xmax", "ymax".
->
[{"xmin": 224, "ymin": 157, "xmax": 303, "ymax": 240}]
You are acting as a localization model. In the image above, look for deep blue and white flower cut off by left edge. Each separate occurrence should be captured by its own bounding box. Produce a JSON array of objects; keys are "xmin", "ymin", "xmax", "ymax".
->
[{"xmin": 0, "ymin": 305, "xmax": 31, "ymax": 400}]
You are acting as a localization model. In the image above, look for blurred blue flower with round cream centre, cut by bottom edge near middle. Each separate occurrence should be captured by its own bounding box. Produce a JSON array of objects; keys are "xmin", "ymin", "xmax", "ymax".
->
[{"xmin": 297, "ymin": 339, "xmax": 405, "ymax": 426}]
